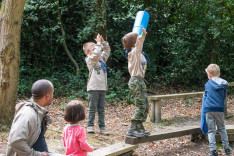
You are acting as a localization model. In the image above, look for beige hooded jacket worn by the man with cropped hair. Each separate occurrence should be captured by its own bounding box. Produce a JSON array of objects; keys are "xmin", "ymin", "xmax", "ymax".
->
[{"xmin": 7, "ymin": 99, "xmax": 47, "ymax": 156}]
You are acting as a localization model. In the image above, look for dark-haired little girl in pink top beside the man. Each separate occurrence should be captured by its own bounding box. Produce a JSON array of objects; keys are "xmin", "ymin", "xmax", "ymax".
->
[{"xmin": 63, "ymin": 100, "xmax": 93, "ymax": 156}]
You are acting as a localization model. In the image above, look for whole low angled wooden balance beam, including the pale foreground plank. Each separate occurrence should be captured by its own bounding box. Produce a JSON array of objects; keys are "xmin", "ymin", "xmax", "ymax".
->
[{"xmin": 88, "ymin": 125, "xmax": 234, "ymax": 156}]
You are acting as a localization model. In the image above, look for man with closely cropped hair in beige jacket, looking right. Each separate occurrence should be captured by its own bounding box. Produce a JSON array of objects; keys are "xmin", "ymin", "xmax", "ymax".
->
[{"xmin": 7, "ymin": 79, "xmax": 54, "ymax": 156}]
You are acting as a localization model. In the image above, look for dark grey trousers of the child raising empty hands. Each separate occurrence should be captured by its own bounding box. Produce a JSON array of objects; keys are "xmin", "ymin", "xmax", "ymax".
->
[{"xmin": 87, "ymin": 90, "xmax": 106, "ymax": 128}]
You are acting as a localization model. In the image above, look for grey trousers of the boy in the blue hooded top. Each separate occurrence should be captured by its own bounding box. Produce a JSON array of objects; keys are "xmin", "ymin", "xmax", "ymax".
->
[{"xmin": 206, "ymin": 112, "xmax": 229, "ymax": 151}]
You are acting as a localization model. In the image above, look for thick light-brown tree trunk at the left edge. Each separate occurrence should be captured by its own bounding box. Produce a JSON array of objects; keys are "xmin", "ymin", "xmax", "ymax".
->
[{"xmin": 0, "ymin": 0, "xmax": 25, "ymax": 124}]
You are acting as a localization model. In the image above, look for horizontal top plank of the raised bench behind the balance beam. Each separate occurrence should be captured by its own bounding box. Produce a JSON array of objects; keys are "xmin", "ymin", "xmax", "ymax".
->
[{"xmin": 148, "ymin": 92, "xmax": 204, "ymax": 101}]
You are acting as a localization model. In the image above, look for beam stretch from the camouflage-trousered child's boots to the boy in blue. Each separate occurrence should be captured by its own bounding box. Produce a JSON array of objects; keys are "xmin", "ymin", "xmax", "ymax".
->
[{"xmin": 125, "ymin": 126, "xmax": 201, "ymax": 144}]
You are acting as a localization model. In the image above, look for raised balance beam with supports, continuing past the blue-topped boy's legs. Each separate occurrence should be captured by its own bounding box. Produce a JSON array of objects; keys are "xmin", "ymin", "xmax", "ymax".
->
[{"xmin": 125, "ymin": 125, "xmax": 234, "ymax": 145}]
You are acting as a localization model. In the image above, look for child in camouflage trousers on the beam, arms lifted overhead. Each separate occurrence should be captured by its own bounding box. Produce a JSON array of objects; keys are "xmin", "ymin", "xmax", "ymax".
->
[{"xmin": 122, "ymin": 28, "xmax": 150, "ymax": 137}]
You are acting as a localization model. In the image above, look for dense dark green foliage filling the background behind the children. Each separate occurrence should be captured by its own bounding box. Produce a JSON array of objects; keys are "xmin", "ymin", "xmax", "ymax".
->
[{"xmin": 19, "ymin": 0, "xmax": 234, "ymax": 103}]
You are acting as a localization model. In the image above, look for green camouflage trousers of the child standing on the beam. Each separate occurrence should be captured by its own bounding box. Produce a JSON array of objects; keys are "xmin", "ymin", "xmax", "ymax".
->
[{"xmin": 128, "ymin": 76, "xmax": 149, "ymax": 123}]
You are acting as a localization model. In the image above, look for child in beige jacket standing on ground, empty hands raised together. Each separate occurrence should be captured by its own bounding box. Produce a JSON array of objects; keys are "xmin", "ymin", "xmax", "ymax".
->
[{"xmin": 83, "ymin": 34, "xmax": 110, "ymax": 135}]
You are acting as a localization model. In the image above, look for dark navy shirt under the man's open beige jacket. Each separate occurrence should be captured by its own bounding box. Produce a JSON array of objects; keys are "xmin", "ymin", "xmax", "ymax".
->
[{"xmin": 32, "ymin": 119, "xmax": 49, "ymax": 152}]
